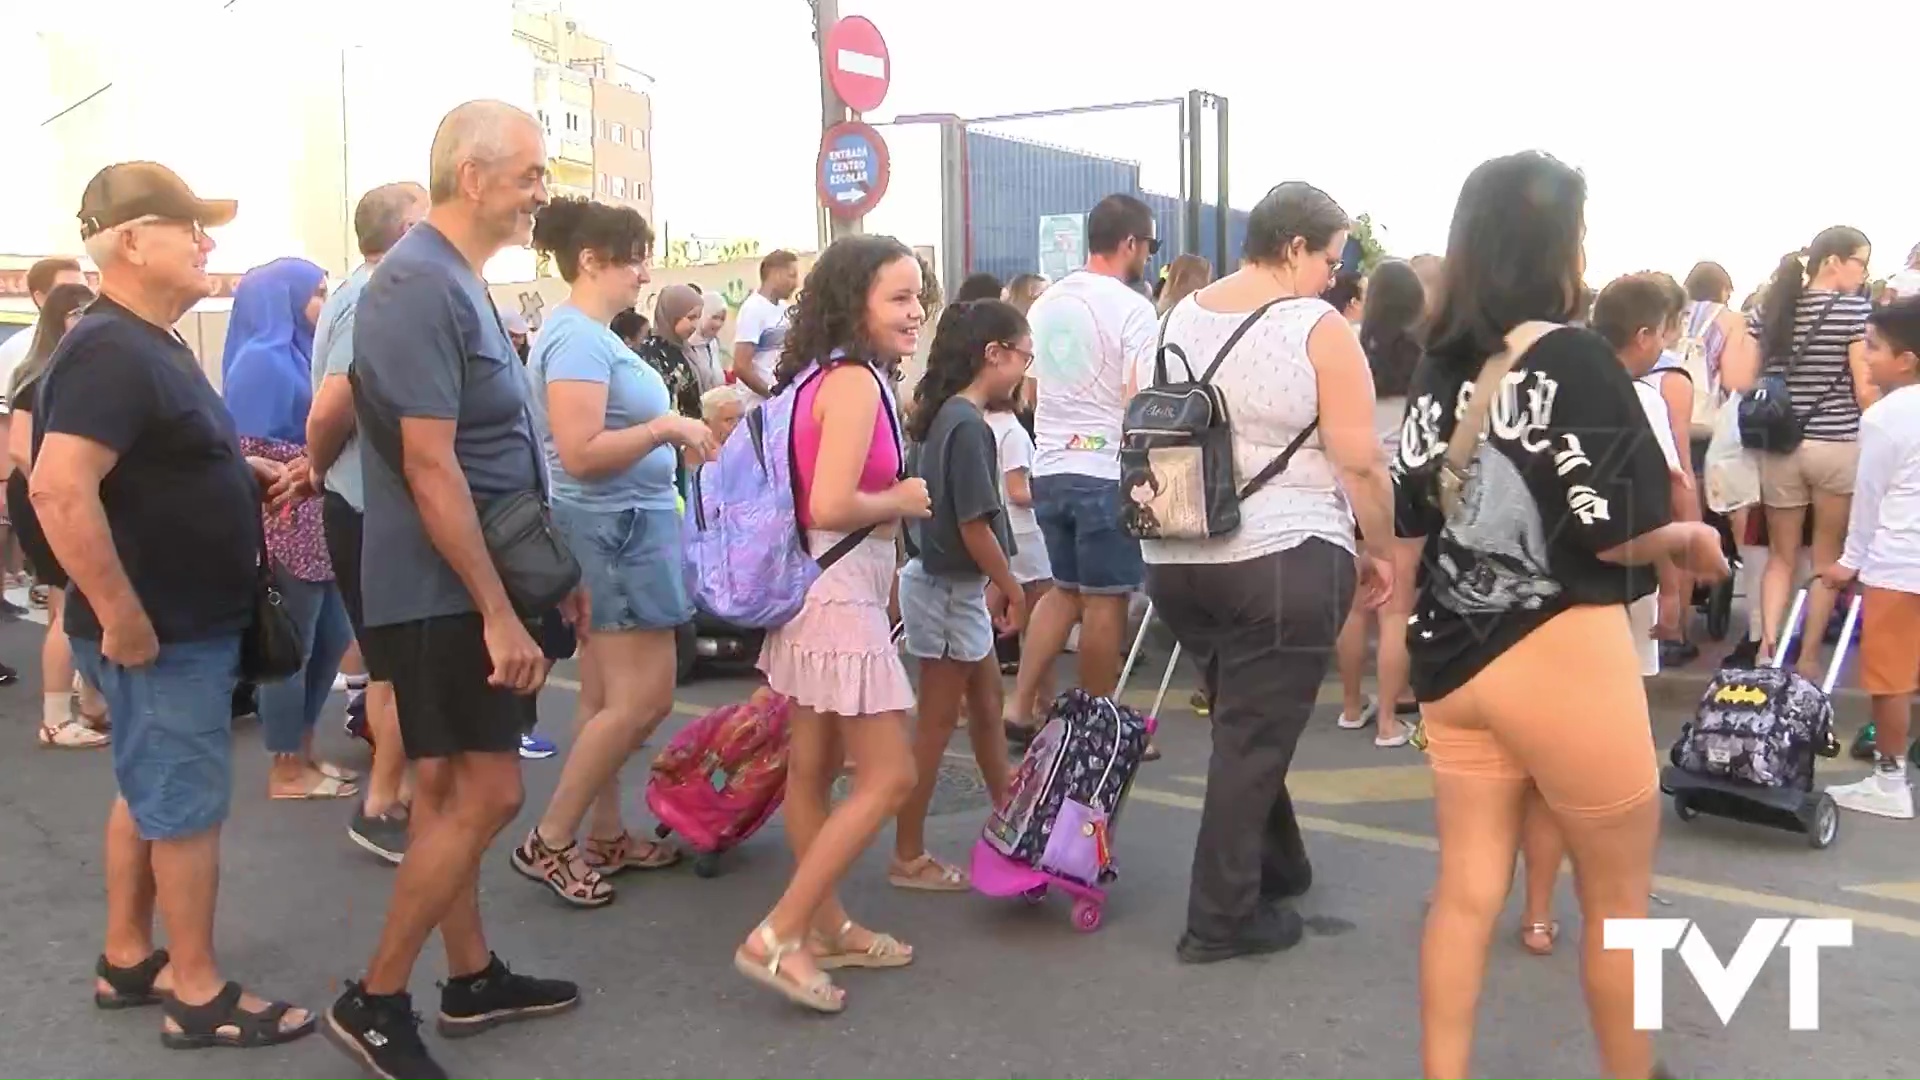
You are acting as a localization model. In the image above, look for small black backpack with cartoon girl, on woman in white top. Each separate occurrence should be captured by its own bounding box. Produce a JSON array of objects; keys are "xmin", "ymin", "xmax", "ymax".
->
[{"xmin": 1119, "ymin": 296, "xmax": 1319, "ymax": 540}]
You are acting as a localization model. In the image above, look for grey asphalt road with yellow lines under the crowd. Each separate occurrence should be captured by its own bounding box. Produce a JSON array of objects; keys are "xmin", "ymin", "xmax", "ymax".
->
[{"xmin": 0, "ymin": 625, "xmax": 1920, "ymax": 1080}]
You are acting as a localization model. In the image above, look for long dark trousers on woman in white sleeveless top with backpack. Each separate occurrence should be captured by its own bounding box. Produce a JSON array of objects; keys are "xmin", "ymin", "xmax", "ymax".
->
[{"xmin": 1146, "ymin": 540, "xmax": 1356, "ymax": 942}]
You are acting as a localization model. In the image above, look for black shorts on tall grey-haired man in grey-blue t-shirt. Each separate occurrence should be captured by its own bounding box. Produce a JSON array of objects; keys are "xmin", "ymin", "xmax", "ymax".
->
[{"xmin": 359, "ymin": 614, "xmax": 538, "ymax": 761}]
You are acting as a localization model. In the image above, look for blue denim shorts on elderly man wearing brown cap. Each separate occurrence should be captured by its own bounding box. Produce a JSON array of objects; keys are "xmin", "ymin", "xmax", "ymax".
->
[{"xmin": 73, "ymin": 634, "xmax": 240, "ymax": 840}]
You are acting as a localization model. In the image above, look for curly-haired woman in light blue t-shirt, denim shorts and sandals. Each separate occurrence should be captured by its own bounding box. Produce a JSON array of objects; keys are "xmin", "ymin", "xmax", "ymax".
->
[{"xmin": 513, "ymin": 198, "xmax": 714, "ymax": 907}]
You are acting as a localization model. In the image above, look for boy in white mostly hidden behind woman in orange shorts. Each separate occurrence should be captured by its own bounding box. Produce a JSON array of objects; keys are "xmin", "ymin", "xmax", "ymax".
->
[{"xmin": 1592, "ymin": 273, "xmax": 1695, "ymax": 676}]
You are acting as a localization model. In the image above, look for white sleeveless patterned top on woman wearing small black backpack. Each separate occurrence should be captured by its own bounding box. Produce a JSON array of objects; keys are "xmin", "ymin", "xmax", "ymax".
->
[{"xmin": 1123, "ymin": 296, "xmax": 1354, "ymax": 563}]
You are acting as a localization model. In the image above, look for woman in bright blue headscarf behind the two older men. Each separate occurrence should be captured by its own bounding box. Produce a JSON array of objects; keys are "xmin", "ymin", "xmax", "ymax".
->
[{"xmin": 221, "ymin": 259, "xmax": 359, "ymax": 799}]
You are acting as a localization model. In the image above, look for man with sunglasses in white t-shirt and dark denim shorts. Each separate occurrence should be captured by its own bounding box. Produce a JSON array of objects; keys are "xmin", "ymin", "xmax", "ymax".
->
[{"xmin": 1008, "ymin": 194, "xmax": 1160, "ymax": 746}]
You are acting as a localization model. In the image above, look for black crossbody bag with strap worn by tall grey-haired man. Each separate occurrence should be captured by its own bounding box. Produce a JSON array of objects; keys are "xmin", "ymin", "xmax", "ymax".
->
[{"xmin": 348, "ymin": 300, "xmax": 580, "ymax": 619}]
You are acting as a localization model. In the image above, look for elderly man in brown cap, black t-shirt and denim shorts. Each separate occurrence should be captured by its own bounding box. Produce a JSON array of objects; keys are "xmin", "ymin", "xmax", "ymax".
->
[{"xmin": 31, "ymin": 161, "xmax": 313, "ymax": 1049}]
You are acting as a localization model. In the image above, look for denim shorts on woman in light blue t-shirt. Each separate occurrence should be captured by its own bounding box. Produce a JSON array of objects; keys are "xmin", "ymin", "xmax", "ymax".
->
[{"xmin": 553, "ymin": 502, "xmax": 693, "ymax": 632}]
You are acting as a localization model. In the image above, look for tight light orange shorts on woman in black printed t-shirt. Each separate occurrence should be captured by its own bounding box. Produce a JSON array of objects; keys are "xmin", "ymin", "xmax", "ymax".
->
[{"xmin": 1421, "ymin": 605, "xmax": 1659, "ymax": 817}]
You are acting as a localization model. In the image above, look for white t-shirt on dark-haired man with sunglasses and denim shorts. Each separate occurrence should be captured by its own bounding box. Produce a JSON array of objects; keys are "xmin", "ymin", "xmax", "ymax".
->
[{"xmin": 1027, "ymin": 271, "xmax": 1160, "ymax": 480}]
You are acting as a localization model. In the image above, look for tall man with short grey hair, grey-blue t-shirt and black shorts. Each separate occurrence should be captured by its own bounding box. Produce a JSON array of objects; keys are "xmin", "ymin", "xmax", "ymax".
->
[{"xmin": 326, "ymin": 102, "xmax": 584, "ymax": 1080}]
